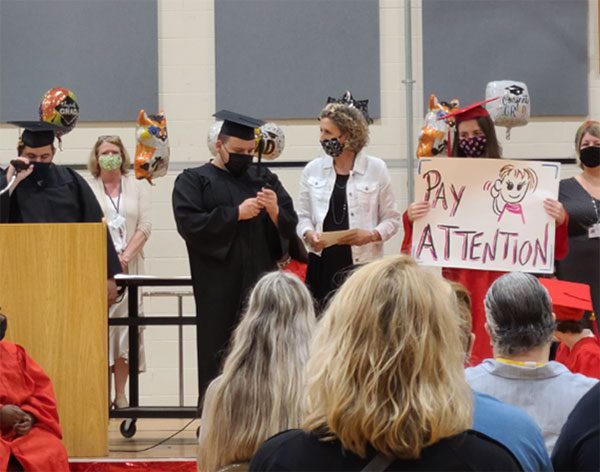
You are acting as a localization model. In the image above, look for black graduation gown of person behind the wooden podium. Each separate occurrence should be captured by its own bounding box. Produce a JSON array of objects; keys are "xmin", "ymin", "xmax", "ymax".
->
[{"xmin": 0, "ymin": 164, "xmax": 121, "ymax": 278}]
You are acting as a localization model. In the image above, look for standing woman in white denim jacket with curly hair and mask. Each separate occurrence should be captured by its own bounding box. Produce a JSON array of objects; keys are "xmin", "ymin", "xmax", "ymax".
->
[{"xmin": 297, "ymin": 103, "xmax": 400, "ymax": 306}]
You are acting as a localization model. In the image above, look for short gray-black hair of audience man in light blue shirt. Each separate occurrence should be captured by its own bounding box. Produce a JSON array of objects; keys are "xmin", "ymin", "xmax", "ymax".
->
[{"xmin": 484, "ymin": 272, "xmax": 556, "ymax": 355}]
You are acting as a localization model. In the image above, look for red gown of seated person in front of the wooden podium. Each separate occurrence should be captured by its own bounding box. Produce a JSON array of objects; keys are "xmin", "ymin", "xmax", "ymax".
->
[{"xmin": 0, "ymin": 341, "xmax": 69, "ymax": 472}]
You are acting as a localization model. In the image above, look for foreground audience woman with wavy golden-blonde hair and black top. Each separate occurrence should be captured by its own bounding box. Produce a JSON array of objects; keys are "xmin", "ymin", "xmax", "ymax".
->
[{"xmin": 250, "ymin": 256, "xmax": 520, "ymax": 471}]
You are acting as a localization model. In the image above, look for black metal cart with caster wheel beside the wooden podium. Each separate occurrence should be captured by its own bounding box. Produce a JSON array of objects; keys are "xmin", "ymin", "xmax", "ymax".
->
[{"xmin": 108, "ymin": 276, "xmax": 198, "ymax": 438}]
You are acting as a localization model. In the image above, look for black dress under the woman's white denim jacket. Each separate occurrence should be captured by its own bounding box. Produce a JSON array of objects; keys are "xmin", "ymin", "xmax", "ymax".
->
[{"xmin": 306, "ymin": 174, "xmax": 352, "ymax": 308}]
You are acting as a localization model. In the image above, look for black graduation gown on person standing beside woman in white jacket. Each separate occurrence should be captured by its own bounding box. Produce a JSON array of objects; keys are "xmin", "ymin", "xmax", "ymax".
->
[{"xmin": 173, "ymin": 164, "xmax": 298, "ymax": 395}]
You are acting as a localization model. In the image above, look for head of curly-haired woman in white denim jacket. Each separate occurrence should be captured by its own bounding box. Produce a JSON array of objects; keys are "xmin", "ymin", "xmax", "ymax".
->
[{"xmin": 319, "ymin": 103, "xmax": 369, "ymax": 157}]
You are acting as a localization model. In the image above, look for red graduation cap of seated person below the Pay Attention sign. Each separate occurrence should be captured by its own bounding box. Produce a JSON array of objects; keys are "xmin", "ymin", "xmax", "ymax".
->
[{"xmin": 539, "ymin": 278, "xmax": 592, "ymax": 321}]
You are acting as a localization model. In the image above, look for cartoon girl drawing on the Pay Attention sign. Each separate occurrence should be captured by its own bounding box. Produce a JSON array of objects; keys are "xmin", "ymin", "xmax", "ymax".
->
[{"xmin": 490, "ymin": 164, "xmax": 538, "ymax": 223}]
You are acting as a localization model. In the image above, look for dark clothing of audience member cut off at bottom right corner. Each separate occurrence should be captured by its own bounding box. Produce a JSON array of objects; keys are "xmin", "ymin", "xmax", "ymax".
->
[{"xmin": 552, "ymin": 383, "xmax": 600, "ymax": 471}]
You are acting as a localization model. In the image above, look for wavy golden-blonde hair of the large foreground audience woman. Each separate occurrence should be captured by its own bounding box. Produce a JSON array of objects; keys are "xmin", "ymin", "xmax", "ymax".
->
[{"xmin": 303, "ymin": 255, "xmax": 472, "ymax": 458}]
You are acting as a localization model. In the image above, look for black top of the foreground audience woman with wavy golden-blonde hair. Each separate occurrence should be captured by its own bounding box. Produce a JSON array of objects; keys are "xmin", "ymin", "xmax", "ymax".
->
[{"xmin": 250, "ymin": 429, "xmax": 522, "ymax": 471}]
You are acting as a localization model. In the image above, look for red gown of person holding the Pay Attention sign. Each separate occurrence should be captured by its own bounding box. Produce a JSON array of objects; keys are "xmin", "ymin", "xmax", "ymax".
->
[{"xmin": 401, "ymin": 212, "xmax": 569, "ymax": 365}]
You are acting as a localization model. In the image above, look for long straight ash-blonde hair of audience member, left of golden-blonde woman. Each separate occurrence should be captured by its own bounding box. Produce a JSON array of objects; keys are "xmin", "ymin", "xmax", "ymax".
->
[{"xmin": 198, "ymin": 272, "xmax": 316, "ymax": 471}]
